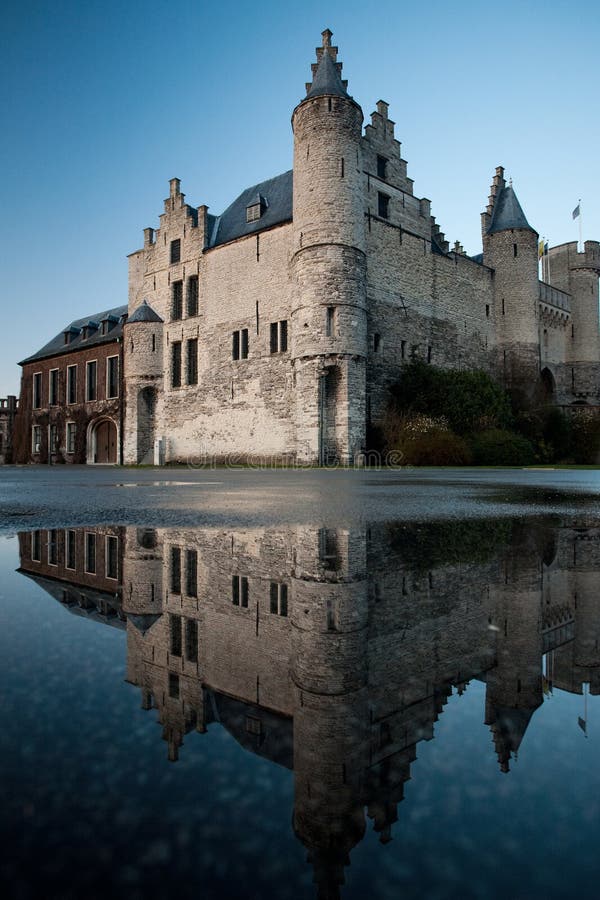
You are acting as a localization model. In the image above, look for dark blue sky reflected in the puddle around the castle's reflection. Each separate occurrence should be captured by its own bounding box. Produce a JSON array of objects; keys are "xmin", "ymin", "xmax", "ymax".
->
[{"xmin": 0, "ymin": 538, "xmax": 600, "ymax": 900}]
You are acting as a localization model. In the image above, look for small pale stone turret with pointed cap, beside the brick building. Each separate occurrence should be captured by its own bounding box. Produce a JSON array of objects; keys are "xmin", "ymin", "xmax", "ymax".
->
[{"xmin": 123, "ymin": 300, "xmax": 164, "ymax": 465}]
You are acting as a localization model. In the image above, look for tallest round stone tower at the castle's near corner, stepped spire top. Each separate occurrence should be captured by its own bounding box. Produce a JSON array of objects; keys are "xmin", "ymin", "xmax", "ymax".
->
[{"xmin": 291, "ymin": 30, "xmax": 367, "ymax": 463}]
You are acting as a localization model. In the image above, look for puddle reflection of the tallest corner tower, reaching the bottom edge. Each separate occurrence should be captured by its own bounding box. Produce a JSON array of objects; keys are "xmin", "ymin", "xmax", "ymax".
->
[{"xmin": 292, "ymin": 529, "xmax": 369, "ymax": 900}]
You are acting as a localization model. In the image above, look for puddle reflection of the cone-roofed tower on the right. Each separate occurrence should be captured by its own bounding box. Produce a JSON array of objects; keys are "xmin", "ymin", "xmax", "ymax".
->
[{"xmin": 486, "ymin": 528, "xmax": 543, "ymax": 772}]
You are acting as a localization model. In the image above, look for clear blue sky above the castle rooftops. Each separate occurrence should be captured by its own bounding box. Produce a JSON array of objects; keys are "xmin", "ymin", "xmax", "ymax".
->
[{"xmin": 0, "ymin": 0, "xmax": 600, "ymax": 396}]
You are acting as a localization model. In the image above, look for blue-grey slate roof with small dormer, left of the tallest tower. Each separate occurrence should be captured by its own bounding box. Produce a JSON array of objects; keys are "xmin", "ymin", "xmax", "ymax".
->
[{"xmin": 208, "ymin": 169, "xmax": 293, "ymax": 247}]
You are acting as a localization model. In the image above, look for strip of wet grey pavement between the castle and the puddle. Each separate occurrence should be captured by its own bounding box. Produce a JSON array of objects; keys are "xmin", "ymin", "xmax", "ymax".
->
[{"xmin": 0, "ymin": 466, "xmax": 600, "ymax": 533}]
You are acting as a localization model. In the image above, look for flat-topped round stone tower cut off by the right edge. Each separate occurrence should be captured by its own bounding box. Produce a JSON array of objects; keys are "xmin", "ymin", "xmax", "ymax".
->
[{"xmin": 549, "ymin": 241, "xmax": 600, "ymax": 401}]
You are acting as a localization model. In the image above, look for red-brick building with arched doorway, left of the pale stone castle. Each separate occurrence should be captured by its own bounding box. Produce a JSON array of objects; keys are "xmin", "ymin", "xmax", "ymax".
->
[{"xmin": 15, "ymin": 307, "xmax": 127, "ymax": 463}]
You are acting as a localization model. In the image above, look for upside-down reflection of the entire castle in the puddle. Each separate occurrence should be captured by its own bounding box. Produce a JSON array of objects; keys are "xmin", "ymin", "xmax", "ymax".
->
[{"xmin": 20, "ymin": 522, "xmax": 600, "ymax": 897}]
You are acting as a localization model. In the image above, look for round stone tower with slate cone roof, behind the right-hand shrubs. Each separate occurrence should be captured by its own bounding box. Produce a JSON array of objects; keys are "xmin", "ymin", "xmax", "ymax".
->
[{"xmin": 481, "ymin": 166, "xmax": 540, "ymax": 389}]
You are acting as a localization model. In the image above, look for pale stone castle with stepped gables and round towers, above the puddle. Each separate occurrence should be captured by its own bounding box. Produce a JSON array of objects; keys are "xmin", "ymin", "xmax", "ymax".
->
[{"xmin": 14, "ymin": 30, "xmax": 600, "ymax": 464}]
